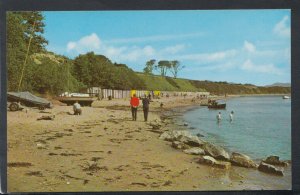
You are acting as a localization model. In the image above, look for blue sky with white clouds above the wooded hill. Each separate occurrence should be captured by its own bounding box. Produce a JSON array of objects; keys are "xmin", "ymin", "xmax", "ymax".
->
[{"xmin": 43, "ymin": 10, "xmax": 291, "ymax": 85}]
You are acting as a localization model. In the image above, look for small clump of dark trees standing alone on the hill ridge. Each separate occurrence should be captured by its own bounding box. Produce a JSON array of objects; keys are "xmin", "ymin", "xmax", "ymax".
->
[{"xmin": 144, "ymin": 59, "xmax": 185, "ymax": 78}]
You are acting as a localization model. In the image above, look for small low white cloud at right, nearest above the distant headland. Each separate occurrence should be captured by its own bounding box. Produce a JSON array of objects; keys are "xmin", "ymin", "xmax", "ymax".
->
[{"xmin": 241, "ymin": 59, "xmax": 282, "ymax": 75}]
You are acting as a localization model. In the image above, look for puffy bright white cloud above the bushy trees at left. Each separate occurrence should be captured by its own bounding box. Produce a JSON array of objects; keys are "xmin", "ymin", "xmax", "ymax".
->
[{"xmin": 67, "ymin": 33, "xmax": 101, "ymax": 53}]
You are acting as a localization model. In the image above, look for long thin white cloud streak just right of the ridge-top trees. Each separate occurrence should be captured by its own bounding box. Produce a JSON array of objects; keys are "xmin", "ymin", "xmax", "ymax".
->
[{"xmin": 177, "ymin": 49, "xmax": 237, "ymax": 64}]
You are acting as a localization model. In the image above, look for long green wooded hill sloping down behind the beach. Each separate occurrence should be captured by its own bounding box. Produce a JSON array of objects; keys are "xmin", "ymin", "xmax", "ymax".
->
[{"xmin": 7, "ymin": 12, "xmax": 291, "ymax": 95}]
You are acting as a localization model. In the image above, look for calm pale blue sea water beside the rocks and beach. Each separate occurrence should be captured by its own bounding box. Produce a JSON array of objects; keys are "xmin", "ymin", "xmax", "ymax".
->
[{"xmin": 183, "ymin": 96, "xmax": 291, "ymax": 160}]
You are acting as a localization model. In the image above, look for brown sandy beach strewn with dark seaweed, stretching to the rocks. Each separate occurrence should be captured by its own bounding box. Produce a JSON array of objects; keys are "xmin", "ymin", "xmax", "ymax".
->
[{"xmin": 7, "ymin": 97, "xmax": 291, "ymax": 192}]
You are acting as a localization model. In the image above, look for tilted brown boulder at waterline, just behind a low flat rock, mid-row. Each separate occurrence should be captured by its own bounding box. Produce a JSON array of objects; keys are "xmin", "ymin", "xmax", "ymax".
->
[{"xmin": 203, "ymin": 142, "xmax": 230, "ymax": 161}]
